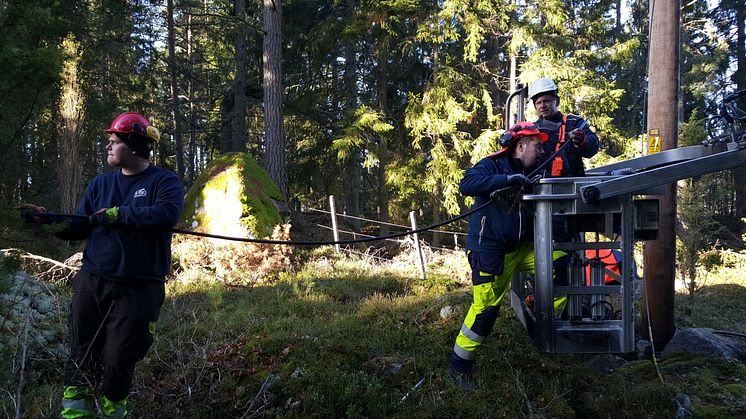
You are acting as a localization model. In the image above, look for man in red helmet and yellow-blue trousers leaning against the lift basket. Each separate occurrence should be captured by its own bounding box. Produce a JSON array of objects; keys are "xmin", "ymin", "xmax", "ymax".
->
[{"xmin": 450, "ymin": 122, "xmax": 548, "ymax": 391}]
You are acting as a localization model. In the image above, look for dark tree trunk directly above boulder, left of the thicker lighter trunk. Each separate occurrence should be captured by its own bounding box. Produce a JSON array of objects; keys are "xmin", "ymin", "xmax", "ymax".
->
[{"xmin": 230, "ymin": 0, "xmax": 246, "ymax": 152}]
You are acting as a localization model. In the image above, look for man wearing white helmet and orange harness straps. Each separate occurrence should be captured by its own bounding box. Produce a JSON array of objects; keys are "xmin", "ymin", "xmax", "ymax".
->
[{"xmin": 528, "ymin": 77, "xmax": 598, "ymax": 177}]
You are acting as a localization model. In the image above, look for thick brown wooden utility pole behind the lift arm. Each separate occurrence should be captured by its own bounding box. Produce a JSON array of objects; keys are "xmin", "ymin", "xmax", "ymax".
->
[{"xmin": 642, "ymin": 0, "xmax": 681, "ymax": 350}]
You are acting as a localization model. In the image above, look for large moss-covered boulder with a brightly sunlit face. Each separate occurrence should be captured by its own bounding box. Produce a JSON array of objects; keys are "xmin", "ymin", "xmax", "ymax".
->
[{"xmin": 182, "ymin": 153, "xmax": 283, "ymax": 238}]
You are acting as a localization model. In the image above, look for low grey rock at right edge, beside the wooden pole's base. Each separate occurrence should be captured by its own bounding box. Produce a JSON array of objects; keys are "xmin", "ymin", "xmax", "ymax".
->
[{"xmin": 663, "ymin": 327, "xmax": 746, "ymax": 361}]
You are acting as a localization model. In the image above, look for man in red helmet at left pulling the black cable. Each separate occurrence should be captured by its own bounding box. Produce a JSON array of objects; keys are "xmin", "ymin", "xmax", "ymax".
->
[{"xmin": 25, "ymin": 112, "xmax": 184, "ymax": 418}]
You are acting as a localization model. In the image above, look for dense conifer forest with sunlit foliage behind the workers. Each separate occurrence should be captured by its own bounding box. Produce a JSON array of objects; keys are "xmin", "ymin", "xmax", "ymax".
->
[{"xmin": 0, "ymin": 0, "xmax": 746, "ymax": 416}]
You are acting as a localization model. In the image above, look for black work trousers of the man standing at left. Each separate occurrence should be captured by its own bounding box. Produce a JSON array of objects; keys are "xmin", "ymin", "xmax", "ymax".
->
[{"xmin": 65, "ymin": 271, "xmax": 165, "ymax": 402}]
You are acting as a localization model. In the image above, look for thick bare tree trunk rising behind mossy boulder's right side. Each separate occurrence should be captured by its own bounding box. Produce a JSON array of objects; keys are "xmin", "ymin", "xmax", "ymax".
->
[{"xmin": 263, "ymin": 0, "xmax": 288, "ymax": 203}]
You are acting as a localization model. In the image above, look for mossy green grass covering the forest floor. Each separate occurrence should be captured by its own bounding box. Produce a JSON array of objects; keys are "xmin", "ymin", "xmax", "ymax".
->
[{"xmin": 0, "ymin": 249, "xmax": 746, "ymax": 418}]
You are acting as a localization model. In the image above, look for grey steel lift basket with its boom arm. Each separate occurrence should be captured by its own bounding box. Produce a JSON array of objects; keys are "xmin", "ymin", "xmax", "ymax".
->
[{"xmin": 510, "ymin": 142, "xmax": 746, "ymax": 353}]
